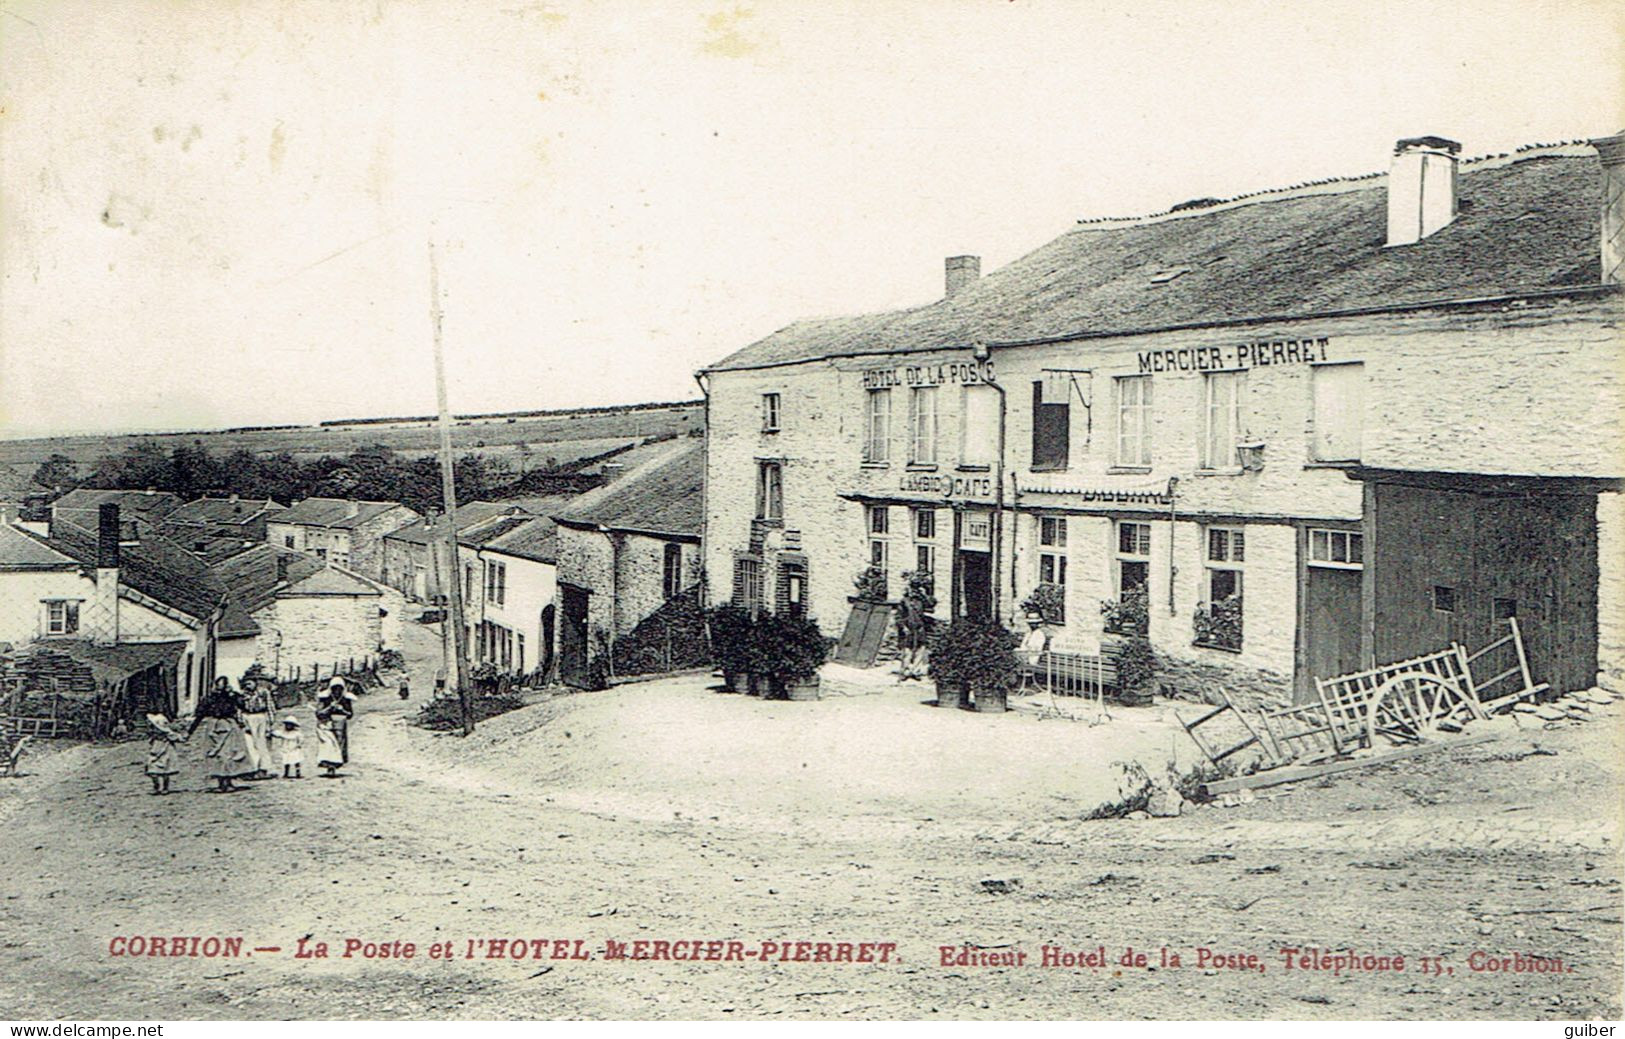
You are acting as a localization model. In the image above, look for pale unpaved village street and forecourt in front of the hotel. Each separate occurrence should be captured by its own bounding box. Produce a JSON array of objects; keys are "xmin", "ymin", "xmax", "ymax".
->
[{"xmin": 0, "ymin": 628, "xmax": 1622, "ymax": 1019}]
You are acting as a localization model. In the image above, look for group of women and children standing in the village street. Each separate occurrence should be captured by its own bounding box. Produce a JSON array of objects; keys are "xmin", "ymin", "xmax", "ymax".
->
[{"xmin": 146, "ymin": 676, "xmax": 377, "ymax": 795}]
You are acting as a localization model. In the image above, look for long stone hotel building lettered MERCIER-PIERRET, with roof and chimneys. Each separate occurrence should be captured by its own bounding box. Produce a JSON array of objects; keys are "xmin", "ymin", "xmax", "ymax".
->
[{"xmin": 705, "ymin": 138, "xmax": 1625, "ymax": 701}]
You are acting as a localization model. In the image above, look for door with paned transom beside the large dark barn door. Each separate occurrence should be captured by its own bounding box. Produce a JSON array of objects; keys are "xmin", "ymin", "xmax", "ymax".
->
[{"xmin": 1297, "ymin": 528, "xmax": 1365, "ymax": 702}]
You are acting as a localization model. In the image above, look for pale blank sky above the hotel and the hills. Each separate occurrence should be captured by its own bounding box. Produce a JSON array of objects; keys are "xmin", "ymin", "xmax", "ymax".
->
[{"xmin": 0, "ymin": 0, "xmax": 1625, "ymax": 436}]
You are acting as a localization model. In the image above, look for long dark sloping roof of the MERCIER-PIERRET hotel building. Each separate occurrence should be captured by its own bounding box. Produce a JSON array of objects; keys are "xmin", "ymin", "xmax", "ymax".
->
[{"xmin": 709, "ymin": 146, "xmax": 1601, "ymax": 371}]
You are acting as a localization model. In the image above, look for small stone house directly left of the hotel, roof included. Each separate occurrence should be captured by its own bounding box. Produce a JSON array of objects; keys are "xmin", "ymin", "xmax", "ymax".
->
[{"xmin": 554, "ymin": 437, "xmax": 705, "ymax": 686}]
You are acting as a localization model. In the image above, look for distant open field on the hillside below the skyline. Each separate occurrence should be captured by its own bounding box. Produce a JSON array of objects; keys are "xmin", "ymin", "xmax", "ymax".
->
[{"xmin": 0, "ymin": 402, "xmax": 705, "ymax": 472}]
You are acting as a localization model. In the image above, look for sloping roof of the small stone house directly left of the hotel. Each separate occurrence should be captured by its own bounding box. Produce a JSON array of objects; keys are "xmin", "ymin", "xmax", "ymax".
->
[{"xmin": 554, "ymin": 437, "xmax": 705, "ymax": 538}]
